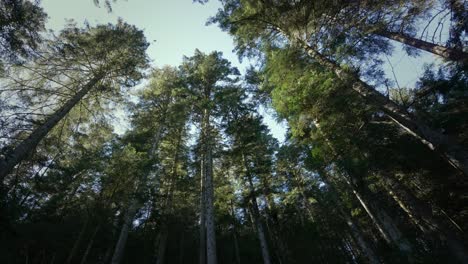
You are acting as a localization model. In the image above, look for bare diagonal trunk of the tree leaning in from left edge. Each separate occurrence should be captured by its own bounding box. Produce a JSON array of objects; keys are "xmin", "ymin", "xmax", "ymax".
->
[{"xmin": 0, "ymin": 76, "xmax": 101, "ymax": 182}]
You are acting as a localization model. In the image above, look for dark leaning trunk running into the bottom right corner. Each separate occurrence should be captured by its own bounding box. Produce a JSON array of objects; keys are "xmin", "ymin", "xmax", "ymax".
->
[{"xmin": 381, "ymin": 174, "xmax": 468, "ymax": 263}]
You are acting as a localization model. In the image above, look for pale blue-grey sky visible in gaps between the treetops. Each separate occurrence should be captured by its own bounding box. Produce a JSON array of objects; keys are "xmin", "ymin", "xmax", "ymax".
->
[{"xmin": 42, "ymin": 0, "xmax": 442, "ymax": 142}]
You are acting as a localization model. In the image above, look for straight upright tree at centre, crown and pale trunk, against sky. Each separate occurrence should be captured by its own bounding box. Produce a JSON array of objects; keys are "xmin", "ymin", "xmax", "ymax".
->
[{"xmin": 180, "ymin": 50, "xmax": 239, "ymax": 264}]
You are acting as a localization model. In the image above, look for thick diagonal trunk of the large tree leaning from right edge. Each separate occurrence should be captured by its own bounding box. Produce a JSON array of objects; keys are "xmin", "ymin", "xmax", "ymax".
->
[{"xmin": 298, "ymin": 39, "xmax": 468, "ymax": 176}]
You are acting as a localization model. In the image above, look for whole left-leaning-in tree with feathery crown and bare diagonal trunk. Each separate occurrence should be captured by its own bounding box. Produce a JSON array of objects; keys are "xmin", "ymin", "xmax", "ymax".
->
[{"xmin": 0, "ymin": 21, "xmax": 148, "ymax": 180}]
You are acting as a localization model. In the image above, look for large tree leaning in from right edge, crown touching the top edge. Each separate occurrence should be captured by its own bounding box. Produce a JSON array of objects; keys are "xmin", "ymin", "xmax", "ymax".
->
[{"xmin": 213, "ymin": 0, "xmax": 468, "ymax": 175}]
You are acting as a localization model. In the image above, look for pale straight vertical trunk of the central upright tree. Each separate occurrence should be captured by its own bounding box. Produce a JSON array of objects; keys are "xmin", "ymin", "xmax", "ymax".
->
[{"xmin": 202, "ymin": 109, "xmax": 217, "ymax": 264}]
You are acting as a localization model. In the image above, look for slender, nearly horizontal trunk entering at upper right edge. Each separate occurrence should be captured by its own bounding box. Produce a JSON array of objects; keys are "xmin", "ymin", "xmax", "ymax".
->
[{"xmin": 375, "ymin": 30, "xmax": 468, "ymax": 62}]
